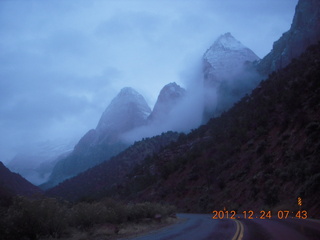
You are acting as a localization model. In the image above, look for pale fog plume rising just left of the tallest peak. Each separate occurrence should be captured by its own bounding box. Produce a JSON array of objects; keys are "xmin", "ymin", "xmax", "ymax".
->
[{"xmin": 121, "ymin": 58, "xmax": 204, "ymax": 144}]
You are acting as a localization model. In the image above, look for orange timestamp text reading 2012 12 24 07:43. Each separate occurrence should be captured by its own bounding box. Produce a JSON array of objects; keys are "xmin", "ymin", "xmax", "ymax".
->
[{"xmin": 212, "ymin": 210, "xmax": 308, "ymax": 219}]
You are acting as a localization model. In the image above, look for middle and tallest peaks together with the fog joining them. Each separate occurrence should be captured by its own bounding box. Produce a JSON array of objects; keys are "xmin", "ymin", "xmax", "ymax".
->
[{"xmin": 122, "ymin": 36, "xmax": 262, "ymax": 143}]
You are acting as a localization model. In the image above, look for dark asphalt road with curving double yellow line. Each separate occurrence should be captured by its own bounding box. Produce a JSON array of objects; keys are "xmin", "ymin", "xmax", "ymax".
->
[{"xmin": 120, "ymin": 214, "xmax": 320, "ymax": 240}]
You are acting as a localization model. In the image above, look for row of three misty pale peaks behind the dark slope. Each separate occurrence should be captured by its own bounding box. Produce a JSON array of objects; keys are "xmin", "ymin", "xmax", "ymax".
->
[{"xmin": 43, "ymin": 33, "xmax": 276, "ymax": 188}]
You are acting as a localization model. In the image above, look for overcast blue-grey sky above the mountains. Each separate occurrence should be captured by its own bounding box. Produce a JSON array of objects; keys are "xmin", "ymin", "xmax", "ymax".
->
[{"xmin": 0, "ymin": 0, "xmax": 298, "ymax": 162}]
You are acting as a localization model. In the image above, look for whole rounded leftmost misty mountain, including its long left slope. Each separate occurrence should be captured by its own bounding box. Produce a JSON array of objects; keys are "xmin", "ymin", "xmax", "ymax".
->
[{"xmin": 41, "ymin": 87, "xmax": 151, "ymax": 189}]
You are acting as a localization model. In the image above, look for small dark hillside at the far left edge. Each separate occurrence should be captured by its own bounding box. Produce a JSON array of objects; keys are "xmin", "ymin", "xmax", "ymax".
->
[{"xmin": 0, "ymin": 162, "xmax": 42, "ymax": 203}]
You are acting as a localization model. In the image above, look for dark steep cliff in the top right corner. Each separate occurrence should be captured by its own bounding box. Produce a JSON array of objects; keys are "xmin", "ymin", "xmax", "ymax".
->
[{"xmin": 257, "ymin": 0, "xmax": 320, "ymax": 75}]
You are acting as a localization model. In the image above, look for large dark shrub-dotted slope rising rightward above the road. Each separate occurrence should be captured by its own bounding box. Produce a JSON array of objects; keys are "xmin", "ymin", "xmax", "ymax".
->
[{"xmin": 47, "ymin": 43, "xmax": 320, "ymax": 217}]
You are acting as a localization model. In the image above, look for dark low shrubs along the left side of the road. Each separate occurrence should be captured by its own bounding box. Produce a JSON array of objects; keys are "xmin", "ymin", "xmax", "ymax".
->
[{"xmin": 0, "ymin": 197, "xmax": 175, "ymax": 240}]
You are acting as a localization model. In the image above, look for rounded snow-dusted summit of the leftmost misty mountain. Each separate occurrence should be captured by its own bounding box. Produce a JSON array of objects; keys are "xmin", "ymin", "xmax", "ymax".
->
[{"xmin": 96, "ymin": 87, "xmax": 151, "ymax": 135}]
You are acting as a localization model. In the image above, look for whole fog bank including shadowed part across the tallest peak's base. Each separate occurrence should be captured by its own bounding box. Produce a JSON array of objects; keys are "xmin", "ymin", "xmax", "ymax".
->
[{"xmin": 121, "ymin": 53, "xmax": 264, "ymax": 144}]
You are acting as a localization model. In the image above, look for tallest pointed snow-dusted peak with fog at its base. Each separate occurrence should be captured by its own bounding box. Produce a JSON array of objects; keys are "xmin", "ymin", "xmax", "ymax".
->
[{"xmin": 203, "ymin": 33, "xmax": 261, "ymax": 120}]
